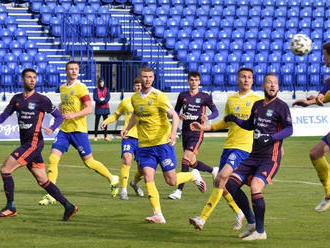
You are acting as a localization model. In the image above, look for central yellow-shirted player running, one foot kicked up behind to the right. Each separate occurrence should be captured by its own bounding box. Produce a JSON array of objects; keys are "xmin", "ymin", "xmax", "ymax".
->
[{"xmin": 121, "ymin": 67, "xmax": 206, "ymax": 223}]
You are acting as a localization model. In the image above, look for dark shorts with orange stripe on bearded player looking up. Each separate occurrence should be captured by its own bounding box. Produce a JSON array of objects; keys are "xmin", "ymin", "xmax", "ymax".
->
[{"xmin": 234, "ymin": 157, "xmax": 280, "ymax": 185}]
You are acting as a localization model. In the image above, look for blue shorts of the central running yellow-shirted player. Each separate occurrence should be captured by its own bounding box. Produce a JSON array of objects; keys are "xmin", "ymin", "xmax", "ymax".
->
[{"xmin": 138, "ymin": 143, "xmax": 176, "ymax": 171}]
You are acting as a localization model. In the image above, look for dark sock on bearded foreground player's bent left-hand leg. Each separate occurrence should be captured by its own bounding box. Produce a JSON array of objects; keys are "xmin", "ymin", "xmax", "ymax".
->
[{"xmin": 226, "ymin": 177, "xmax": 255, "ymax": 224}]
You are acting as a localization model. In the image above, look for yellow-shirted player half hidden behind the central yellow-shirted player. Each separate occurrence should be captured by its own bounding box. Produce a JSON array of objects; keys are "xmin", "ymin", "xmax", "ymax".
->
[{"xmin": 101, "ymin": 77, "xmax": 144, "ymax": 200}]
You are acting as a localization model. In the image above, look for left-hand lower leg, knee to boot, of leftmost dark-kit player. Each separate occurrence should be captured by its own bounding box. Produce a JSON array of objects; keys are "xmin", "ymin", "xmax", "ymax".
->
[{"xmin": 0, "ymin": 155, "xmax": 21, "ymax": 217}]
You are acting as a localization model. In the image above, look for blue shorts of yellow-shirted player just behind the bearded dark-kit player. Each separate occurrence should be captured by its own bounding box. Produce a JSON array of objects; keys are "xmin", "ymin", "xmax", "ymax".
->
[{"xmin": 219, "ymin": 149, "xmax": 250, "ymax": 171}]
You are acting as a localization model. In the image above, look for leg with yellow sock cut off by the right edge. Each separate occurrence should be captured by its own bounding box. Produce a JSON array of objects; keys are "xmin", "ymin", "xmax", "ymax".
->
[{"xmin": 309, "ymin": 133, "xmax": 330, "ymax": 211}]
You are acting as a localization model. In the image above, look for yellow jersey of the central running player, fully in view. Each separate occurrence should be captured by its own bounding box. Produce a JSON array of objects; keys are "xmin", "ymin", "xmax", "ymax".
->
[{"xmin": 131, "ymin": 88, "xmax": 173, "ymax": 147}]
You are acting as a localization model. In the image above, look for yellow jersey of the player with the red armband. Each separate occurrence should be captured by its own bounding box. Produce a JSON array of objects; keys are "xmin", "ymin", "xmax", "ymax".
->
[{"xmin": 60, "ymin": 80, "xmax": 90, "ymax": 133}]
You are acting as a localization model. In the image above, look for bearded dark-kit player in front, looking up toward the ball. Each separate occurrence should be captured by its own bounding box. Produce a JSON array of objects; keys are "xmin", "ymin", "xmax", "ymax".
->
[{"xmin": 224, "ymin": 73, "xmax": 292, "ymax": 240}]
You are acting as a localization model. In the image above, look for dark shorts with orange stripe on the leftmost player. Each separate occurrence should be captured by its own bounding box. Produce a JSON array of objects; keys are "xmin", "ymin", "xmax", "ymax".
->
[{"xmin": 10, "ymin": 142, "xmax": 45, "ymax": 168}]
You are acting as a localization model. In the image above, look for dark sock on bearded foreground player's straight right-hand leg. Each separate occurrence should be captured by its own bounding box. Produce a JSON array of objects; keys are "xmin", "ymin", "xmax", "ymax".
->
[{"xmin": 251, "ymin": 193, "xmax": 266, "ymax": 233}]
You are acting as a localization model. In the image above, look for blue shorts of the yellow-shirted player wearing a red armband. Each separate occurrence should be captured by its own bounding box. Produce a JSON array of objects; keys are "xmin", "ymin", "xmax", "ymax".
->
[{"xmin": 52, "ymin": 130, "xmax": 92, "ymax": 157}]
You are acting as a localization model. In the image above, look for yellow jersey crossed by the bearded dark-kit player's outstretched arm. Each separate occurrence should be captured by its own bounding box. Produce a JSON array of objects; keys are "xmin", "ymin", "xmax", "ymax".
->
[{"xmin": 212, "ymin": 91, "xmax": 262, "ymax": 153}]
